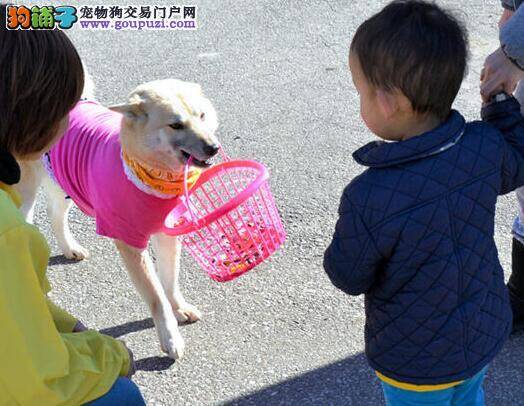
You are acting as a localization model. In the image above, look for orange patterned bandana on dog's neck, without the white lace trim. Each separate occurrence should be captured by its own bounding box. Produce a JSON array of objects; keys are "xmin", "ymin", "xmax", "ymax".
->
[{"xmin": 122, "ymin": 150, "xmax": 202, "ymax": 196}]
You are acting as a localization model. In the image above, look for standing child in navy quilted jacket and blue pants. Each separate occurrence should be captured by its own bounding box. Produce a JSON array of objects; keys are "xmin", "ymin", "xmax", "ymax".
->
[{"xmin": 324, "ymin": 0, "xmax": 524, "ymax": 405}]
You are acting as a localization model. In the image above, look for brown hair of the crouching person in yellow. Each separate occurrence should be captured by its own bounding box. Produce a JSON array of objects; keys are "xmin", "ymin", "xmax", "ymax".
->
[{"xmin": 0, "ymin": 4, "xmax": 84, "ymax": 156}]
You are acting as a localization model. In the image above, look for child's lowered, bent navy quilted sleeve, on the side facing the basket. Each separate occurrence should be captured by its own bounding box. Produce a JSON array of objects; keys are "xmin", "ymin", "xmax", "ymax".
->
[{"xmin": 324, "ymin": 189, "xmax": 381, "ymax": 295}]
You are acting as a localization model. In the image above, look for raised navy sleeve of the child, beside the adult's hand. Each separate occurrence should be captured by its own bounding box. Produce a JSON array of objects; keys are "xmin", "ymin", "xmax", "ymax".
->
[{"xmin": 481, "ymin": 97, "xmax": 524, "ymax": 194}]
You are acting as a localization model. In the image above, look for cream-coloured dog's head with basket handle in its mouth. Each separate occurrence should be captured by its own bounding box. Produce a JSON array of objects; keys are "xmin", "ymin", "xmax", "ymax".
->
[{"xmin": 109, "ymin": 79, "xmax": 219, "ymax": 171}]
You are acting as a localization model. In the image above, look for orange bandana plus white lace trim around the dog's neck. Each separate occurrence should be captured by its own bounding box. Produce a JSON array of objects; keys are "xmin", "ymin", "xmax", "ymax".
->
[{"xmin": 122, "ymin": 149, "xmax": 202, "ymax": 199}]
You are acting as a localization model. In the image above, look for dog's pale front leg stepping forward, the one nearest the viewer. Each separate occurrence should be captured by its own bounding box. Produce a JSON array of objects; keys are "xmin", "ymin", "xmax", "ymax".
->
[{"xmin": 115, "ymin": 240, "xmax": 184, "ymax": 359}]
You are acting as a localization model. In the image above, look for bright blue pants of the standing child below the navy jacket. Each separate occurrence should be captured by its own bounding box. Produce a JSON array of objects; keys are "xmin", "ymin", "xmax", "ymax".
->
[{"xmin": 381, "ymin": 367, "xmax": 488, "ymax": 406}]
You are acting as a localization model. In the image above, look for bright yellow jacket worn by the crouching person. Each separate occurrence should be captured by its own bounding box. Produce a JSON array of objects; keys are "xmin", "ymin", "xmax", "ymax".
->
[{"xmin": 0, "ymin": 183, "xmax": 130, "ymax": 406}]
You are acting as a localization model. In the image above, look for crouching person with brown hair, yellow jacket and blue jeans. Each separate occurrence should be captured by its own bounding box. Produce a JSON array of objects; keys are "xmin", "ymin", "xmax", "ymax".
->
[{"xmin": 0, "ymin": 5, "xmax": 144, "ymax": 406}]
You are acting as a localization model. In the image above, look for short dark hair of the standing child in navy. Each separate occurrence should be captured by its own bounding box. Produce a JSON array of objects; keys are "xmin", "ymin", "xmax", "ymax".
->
[{"xmin": 351, "ymin": 0, "xmax": 468, "ymax": 120}]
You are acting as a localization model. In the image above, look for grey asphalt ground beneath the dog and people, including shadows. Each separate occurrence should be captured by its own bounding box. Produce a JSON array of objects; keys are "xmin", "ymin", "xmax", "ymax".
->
[{"xmin": 25, "ymin": 0, "xmax": 524, "ymax": 406}]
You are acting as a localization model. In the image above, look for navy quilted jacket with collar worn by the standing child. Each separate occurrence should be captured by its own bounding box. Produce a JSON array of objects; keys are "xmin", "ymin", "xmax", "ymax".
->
[{"xmin": 324, "ymin": 98, "xmax": 524, "ymax": 384}]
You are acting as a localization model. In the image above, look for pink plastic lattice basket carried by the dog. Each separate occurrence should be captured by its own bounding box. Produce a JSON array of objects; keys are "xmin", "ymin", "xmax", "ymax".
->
[{"xmin": 164, "ymin": 155, "xmax": 286, "ymax": 282}]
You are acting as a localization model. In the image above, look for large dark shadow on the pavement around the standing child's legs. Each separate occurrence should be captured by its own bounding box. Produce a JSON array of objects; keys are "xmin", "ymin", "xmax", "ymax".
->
[{"xmin": 227, "ymin": 334, "xmax": 524, "ymax": 406}]
